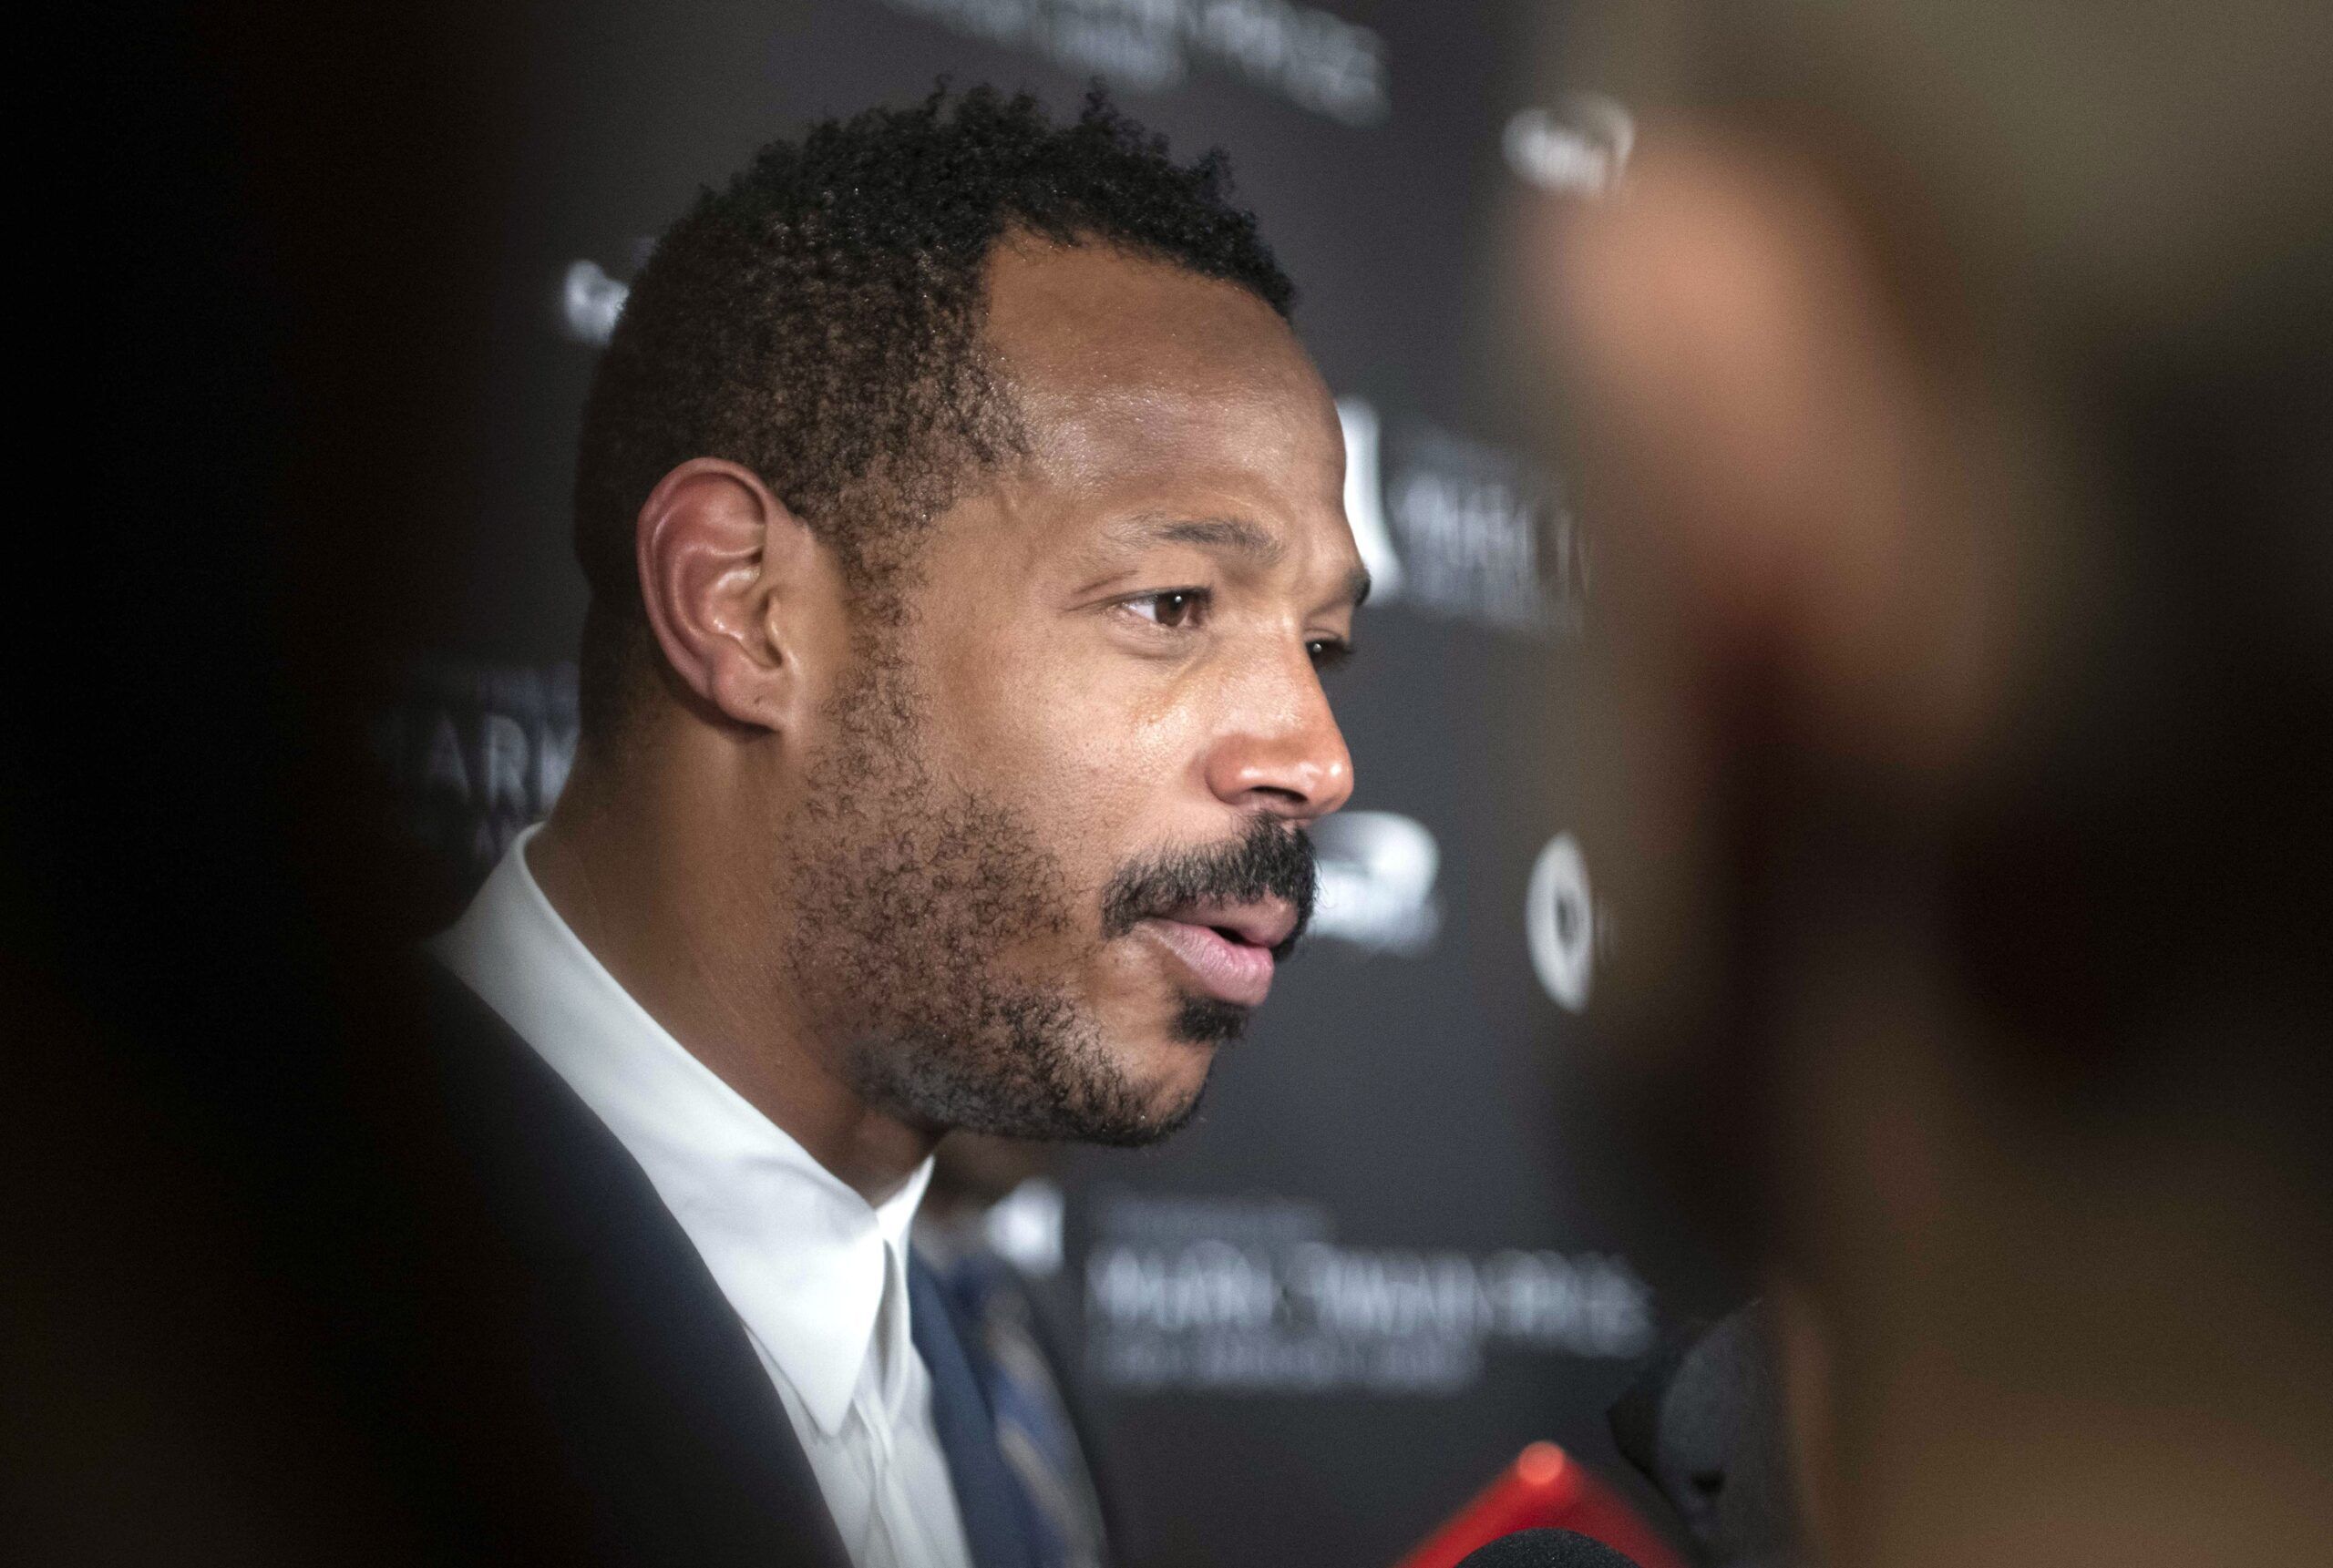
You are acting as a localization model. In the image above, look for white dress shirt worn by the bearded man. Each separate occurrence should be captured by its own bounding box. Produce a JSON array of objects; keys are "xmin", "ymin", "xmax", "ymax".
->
[{"xmin": 429, "ymin": 828, "xmax": 971, "ymax": 1568}]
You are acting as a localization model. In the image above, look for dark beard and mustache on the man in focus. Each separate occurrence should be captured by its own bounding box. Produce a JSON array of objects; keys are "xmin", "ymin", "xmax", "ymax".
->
[{"xmin": 782, "ymin": 651, "xmax": 1313, "ymax": 1145}]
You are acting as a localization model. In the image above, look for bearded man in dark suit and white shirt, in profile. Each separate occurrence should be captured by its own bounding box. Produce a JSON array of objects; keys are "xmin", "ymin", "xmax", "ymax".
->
[{"xmin": 406, "ymin": 91, "xmax": 1367, "ymax": 1568}]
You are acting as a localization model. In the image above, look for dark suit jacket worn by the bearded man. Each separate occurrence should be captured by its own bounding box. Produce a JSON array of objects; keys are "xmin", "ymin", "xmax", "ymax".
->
[{"xmin": 340, "ymin": 964, "xmax": 1026, "ymax": 1568}]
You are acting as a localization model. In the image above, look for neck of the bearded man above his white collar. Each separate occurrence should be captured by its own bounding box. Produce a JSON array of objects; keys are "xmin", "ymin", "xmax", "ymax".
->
[{"xmin": 528, "ymin": 737, "xmax": 938, "ymax": 1204}]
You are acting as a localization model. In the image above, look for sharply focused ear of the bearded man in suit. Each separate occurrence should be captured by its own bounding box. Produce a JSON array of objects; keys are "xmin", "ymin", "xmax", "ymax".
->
[{"xmin": 634, "ymin": 457, "xmax": 842, "ymax": 731}]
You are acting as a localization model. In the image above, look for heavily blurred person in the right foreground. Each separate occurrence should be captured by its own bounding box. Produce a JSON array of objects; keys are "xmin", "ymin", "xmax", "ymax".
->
[{"xmin": 1528, "ymin": 0, "xmax": 2333, "ymax": 1568}]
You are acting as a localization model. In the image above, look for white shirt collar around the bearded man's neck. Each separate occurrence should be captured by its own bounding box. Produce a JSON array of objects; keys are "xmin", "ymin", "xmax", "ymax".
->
[{"xmin": 429, "ymin": 828, "xmax": 930, "ymax": 1432}]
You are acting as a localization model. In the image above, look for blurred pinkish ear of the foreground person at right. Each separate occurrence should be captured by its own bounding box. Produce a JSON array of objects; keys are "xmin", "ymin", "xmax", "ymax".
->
[{"xmin": 1551, "ymin": 136, "xmax": 1988, "ymax": 779}]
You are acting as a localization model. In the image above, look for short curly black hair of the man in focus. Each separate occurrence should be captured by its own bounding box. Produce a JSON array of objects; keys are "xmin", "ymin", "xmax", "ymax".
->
[{"xmin": 574, "ymin": 82, "xmax": 1295, "ymax": 731}]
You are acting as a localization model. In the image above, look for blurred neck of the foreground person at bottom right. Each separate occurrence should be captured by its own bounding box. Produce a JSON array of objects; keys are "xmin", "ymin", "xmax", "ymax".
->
[{"xmin": 1778, "ymin": 1057, "xmax": 2333, "ymax": 1568}]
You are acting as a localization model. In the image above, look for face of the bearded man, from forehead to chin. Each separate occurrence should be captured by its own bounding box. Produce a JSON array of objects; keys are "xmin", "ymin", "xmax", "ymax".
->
[{"xmin": 786, "ymin": 245, "xmax": 1367, "ymax": 1143}]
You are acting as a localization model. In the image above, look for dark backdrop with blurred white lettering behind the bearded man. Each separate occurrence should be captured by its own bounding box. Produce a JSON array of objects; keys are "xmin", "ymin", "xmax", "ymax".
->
[{"xmin": 359, "ymin": 0, "xmax": 1703, "ymax": 1568}]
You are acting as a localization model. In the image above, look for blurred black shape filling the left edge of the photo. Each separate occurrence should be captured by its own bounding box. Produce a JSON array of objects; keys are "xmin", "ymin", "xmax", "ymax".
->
[{"xmin": 14, "ymin": 5, "xmax": 540, "ymax": 1563}]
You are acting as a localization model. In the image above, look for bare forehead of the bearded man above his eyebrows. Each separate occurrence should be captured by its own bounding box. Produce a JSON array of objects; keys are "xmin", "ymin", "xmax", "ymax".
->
[{"xmin": 987, "ymin": 241, "xmax": 1344, "ymax": 508}]
